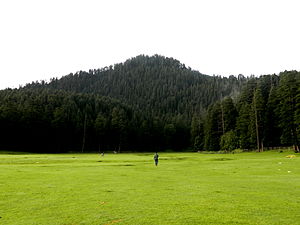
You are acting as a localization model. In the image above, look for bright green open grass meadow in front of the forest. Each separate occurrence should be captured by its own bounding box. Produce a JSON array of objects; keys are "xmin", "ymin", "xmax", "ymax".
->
[{"xmin": 0, "ymin": 152, "xmax": 300, "ymax": 225}]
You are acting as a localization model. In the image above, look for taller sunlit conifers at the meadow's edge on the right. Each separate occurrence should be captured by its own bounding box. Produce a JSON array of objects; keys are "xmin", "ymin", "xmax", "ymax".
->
[{"xmin": 191, "ymin": 71, "xmax": 300, "ymax": 152}]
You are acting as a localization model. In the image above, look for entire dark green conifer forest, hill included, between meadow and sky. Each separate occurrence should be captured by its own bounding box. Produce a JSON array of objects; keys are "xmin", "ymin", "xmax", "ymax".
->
[{"xmin": 0, "ymin": 55, "xmax": 300, "ymax": 152}]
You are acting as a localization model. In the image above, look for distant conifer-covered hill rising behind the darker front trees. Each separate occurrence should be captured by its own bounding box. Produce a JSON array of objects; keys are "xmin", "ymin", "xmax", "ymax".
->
[{"xmin": 25, "ymin": 55, "xmax": 247, "ymax": 121}]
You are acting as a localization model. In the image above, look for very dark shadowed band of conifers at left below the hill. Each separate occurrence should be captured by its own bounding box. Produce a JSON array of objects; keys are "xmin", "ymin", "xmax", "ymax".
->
[{"xmin": 0, "ymin": 89, "xmax": 189, "ymax": 153}]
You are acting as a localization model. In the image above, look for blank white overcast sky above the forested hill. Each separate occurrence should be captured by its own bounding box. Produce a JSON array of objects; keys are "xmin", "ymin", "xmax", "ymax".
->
[{"xmin": 0, "ymin": 0, "xmax": 300, "ymax": 89}]
